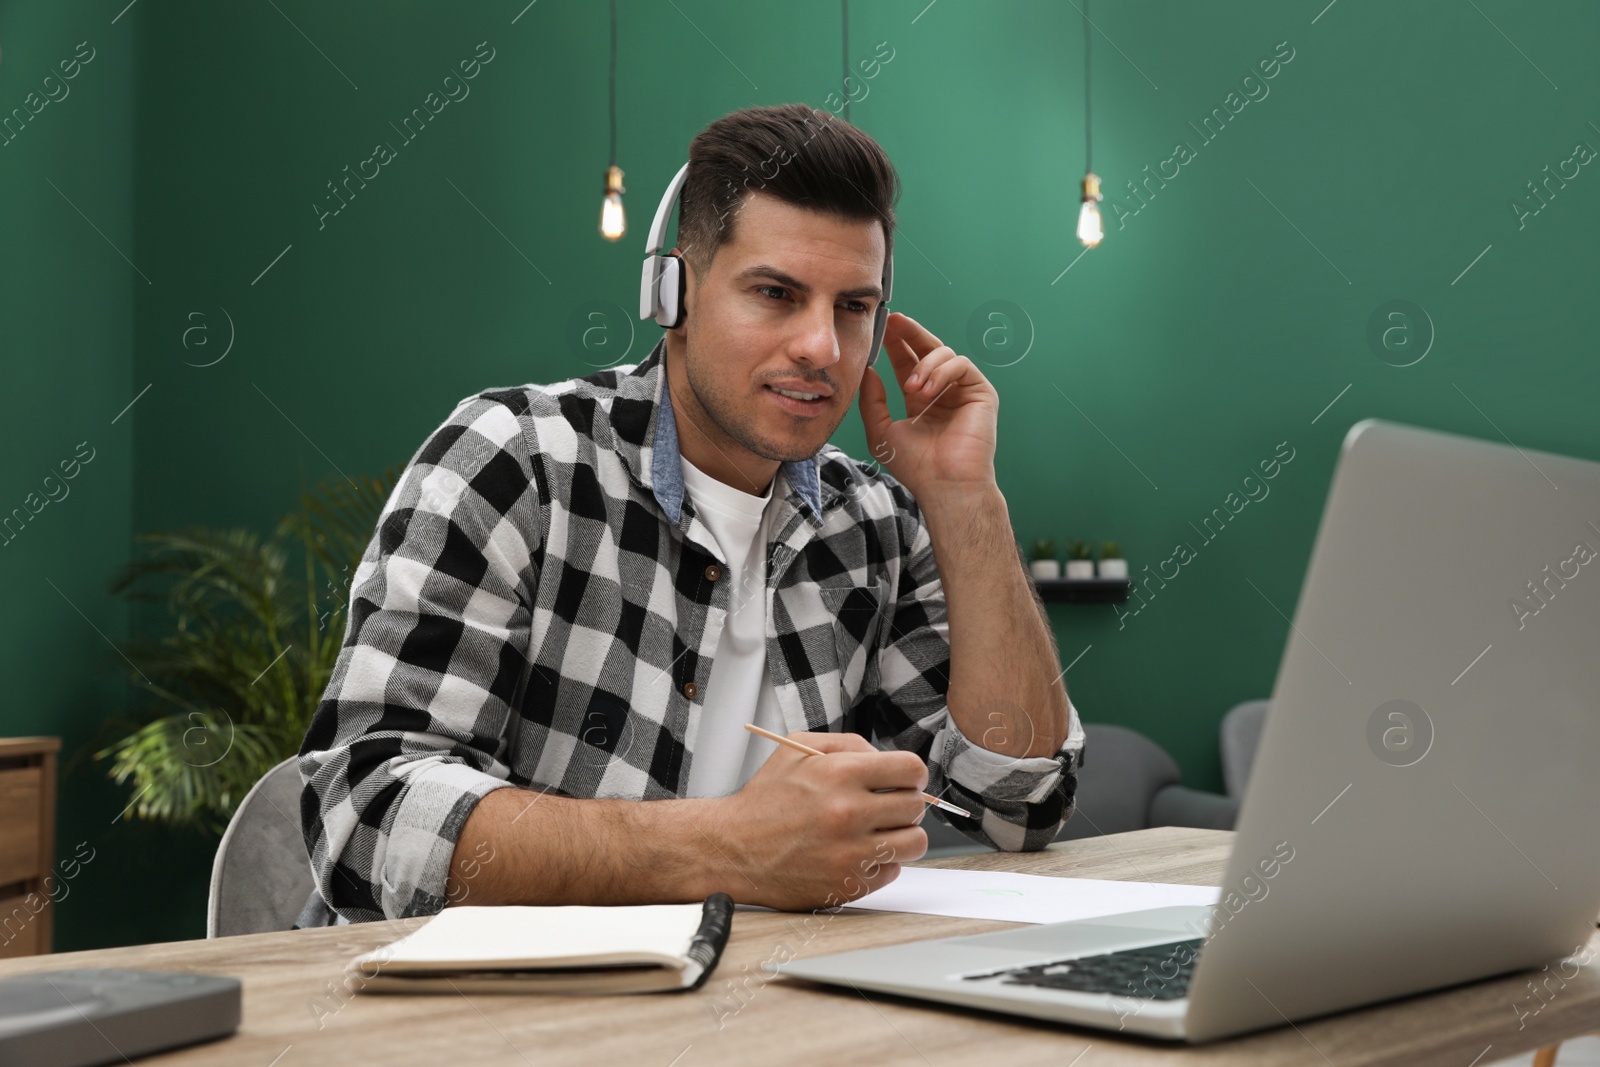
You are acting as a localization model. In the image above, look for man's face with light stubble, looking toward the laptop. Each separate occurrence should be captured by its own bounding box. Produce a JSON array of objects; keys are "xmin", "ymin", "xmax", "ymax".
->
[{"xmin": 668, "ymin": 192, "xmax": 885, "ymax": 462}]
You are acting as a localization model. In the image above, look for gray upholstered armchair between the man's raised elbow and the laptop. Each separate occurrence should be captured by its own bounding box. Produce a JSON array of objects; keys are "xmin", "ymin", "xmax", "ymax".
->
[{"xmin": 923, "ymin": 723, "xmax": 1238, "ymax": 857}]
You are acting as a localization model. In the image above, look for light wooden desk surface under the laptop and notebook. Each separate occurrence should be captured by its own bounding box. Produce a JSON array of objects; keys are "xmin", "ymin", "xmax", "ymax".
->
[{"xmin": 0, "ymin": 827, "xmax": 1600, "ymax": 1067}]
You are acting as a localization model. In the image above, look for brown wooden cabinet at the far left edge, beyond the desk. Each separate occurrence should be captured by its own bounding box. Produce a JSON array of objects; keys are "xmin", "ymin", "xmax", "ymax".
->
[{"xmin": 0, "ymin": 737, "xmax": 61, "ymax": 958}]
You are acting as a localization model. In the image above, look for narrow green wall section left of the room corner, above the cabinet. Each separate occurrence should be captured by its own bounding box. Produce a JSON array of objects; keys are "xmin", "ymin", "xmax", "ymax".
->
[{"xmin": 0, "ymin": 2, "xmax": 168, "ymax": 947}]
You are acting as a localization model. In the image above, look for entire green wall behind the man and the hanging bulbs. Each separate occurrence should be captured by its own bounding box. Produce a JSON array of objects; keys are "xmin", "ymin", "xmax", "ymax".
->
[{"xmin": 0, "ymin": 0, "xmax": 1600, "ymax": 949}]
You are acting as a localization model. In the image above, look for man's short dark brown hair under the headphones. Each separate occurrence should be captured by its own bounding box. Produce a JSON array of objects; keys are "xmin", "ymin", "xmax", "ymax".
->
[{"xmin": 677, "ymin": 104, "xmax": 901, "ymax": 275}]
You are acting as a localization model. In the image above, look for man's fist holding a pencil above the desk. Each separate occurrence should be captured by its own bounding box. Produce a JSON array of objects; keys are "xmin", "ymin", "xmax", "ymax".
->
[{"xmin": 706, "ymin": 733, "xmax": 928, "ymax": 910}]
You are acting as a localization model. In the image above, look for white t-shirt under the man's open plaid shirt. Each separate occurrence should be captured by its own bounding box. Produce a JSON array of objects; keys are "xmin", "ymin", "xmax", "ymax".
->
[{"xmin": 680, "ymin": 456, "xmax": 787, "ymax": 797}]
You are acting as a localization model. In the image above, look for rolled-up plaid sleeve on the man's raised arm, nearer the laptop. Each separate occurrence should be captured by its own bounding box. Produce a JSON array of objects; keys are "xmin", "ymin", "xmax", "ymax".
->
[{"xmin": 869, "ymin": 486, "xmax": 1083, "ymax": 851}]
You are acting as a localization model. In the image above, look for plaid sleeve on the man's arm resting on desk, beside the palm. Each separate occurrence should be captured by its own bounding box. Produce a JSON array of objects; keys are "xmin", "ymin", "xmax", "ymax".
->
[{"xmin": 299, "ymin": 397, "xmax": 539, "ymax": 921}]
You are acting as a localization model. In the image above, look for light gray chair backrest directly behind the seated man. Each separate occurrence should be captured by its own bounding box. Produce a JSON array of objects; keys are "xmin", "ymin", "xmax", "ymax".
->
[{"xmin": 205, "ymin": 757, "xmax": 314, "ymax": 937}]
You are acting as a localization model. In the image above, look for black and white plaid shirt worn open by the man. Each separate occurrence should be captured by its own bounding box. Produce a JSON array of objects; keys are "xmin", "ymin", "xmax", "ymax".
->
[{"xmin": 299, "ymin": 339, "xmax": 1083, "ymax": 921}]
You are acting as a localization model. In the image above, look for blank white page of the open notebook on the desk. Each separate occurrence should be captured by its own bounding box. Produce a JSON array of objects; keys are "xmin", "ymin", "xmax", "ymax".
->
[{"xmin": 374, "ymin": 904, "xmax": 704, "ymax": 968}]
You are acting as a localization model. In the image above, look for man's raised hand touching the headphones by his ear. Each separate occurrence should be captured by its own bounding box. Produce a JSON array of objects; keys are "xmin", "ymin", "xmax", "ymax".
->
[{"xmin": 859, "ymin": 312, "xmax": 1000, "ymax": 499}]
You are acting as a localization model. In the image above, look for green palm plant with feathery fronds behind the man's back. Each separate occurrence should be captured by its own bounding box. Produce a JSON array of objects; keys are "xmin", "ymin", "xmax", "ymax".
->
[{"xmin": 94, "ymin": 467, "xmax": 400, "ymax": 832}]
